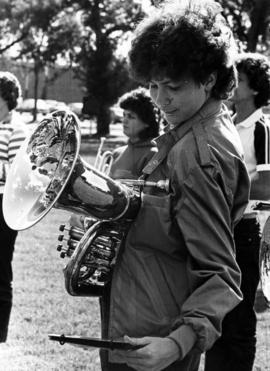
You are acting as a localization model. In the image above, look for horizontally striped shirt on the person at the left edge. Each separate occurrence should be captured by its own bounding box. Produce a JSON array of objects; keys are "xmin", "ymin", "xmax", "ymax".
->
[{"xmin": 0, "ymin": 112, "xmax": 27, "ymax": 193}]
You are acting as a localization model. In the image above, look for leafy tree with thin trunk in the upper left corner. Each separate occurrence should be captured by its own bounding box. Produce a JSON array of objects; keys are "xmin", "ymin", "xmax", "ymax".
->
[{"xmin": 0, "ymin": 0, "xmax": 79, "ymax": 120}]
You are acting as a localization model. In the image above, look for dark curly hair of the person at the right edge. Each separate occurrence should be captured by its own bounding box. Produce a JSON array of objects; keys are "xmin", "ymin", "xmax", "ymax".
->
[{"xmin": 236, "ymin": 53, "xmax": 270, "ymax": 108}]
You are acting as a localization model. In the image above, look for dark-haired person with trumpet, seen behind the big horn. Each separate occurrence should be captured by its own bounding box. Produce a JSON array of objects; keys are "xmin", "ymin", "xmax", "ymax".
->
[{"xmin": 109, "ymin": 87, "xmax": 160, "ymax": 179}]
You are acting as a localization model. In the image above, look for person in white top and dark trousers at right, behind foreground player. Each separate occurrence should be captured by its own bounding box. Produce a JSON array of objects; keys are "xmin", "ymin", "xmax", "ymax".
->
[{"xmin": 205, "ymin": 53, "xmax": 270, "ymax": 371}]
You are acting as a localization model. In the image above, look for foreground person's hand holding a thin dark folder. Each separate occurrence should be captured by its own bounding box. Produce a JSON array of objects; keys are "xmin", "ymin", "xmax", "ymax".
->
[{"xmin": 114, "ymin": 336, "xmax": 180, "ymax": 371}]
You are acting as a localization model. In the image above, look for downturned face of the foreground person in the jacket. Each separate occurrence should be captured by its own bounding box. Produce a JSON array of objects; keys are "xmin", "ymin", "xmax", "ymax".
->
[{"xmin": 149, "ymin": 77, "xmax": 212, "ymax": 126}]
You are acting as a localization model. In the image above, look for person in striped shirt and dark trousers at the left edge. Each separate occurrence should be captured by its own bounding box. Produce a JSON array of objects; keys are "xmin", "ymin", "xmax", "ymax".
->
[{"xmin": 0, "ymin": 71, "xmax": 27, "ymax": 342}]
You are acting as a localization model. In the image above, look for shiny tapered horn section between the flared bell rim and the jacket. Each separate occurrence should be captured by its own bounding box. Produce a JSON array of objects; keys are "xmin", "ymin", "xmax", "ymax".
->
[{"xmin": 55, "ymin": 157, "xmax": 140, "ymax": 220}]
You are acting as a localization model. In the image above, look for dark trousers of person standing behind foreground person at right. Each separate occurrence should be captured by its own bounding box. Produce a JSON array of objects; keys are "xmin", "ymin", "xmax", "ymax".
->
[{"xmin": 204, "ymin": 218, "xmax": 261, "ymax": 371}]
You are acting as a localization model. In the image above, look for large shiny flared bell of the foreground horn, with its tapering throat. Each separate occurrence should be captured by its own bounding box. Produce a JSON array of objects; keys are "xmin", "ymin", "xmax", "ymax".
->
[{"xmin": 3, "ymin": 111, "xmax": 140, "ymax": 230}]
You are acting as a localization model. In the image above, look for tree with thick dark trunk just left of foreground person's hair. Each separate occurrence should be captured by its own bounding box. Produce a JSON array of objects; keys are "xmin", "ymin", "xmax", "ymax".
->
[{"xmin": 65, "ymin": 0, "xmax": 143, "ymax": 137}]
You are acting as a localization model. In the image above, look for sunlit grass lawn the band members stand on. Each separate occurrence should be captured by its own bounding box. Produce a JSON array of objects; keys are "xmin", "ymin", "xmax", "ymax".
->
[{"xmin": 0, "ymin": 150, "xmax": 270, "ymax": 371}]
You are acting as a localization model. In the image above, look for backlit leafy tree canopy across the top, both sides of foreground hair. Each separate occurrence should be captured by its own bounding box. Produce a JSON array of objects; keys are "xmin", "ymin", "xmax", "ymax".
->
[{"xmin": 0, "ymin": 0, "xmax": 270, "ymax": 136}]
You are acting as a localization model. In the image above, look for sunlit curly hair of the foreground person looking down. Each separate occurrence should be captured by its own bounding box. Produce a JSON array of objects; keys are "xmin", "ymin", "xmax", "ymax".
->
[{"xmin": 129, "ymin": 0, "xmax": 237, "ymax": 99}]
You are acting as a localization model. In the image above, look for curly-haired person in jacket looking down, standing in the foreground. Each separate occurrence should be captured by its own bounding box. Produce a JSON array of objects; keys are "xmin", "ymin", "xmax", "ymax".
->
[{"xmin": 96, "ymin": 0, "xmax": 250, "ymax": 371}]
